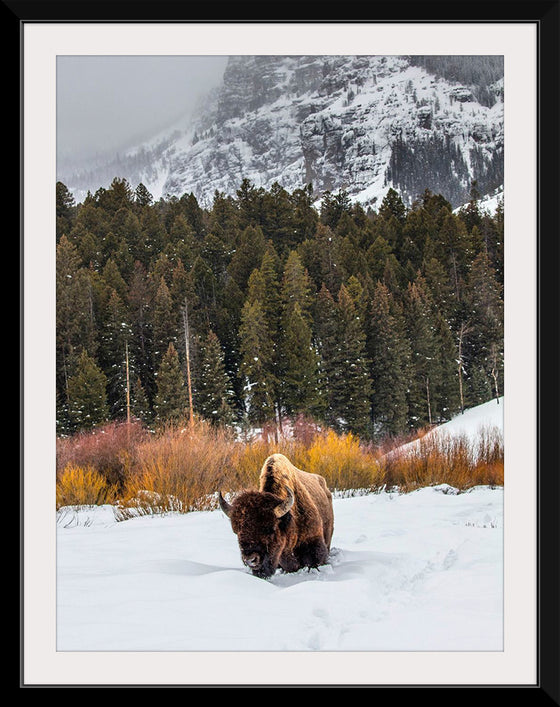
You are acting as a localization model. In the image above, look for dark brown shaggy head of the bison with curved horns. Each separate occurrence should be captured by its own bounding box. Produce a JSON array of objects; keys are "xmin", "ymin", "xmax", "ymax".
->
[{"xmin": 219, "ymin": 489, "xmax": 294, "ymax": 579}]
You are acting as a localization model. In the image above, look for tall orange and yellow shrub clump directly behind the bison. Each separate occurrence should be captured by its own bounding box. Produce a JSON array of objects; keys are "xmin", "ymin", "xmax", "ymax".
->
[{"xmin": 119, "ymin": 422, "xmax": 381, "ymax": 513}]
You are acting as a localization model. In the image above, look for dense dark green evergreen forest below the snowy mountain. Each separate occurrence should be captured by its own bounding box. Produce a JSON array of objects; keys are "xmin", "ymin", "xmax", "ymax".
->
[{"xmin": 56, "ymin": 178, "xmax": 503, "ymax": 440}]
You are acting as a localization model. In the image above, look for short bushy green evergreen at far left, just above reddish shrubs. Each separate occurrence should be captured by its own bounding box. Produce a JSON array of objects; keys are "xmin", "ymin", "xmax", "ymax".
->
[{"xmin": 68, "ymin": 349, "xmax": 109, "ymax": 430}]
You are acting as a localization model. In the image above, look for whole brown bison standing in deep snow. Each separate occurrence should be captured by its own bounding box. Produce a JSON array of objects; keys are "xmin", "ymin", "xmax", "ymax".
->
[{"xmin": 218, "ymin": 454, "xmax": 334, "ymax": 579}]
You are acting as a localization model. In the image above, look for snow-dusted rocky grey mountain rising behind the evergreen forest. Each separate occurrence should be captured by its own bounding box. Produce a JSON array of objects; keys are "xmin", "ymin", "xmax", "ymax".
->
[{"xmin": 58, "ymin": 56, "xmax": 504, "ymax": 208}]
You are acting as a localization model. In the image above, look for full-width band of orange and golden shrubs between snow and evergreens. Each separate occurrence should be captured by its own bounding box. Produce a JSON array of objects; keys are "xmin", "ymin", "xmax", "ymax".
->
[{"xmin": 57, "ymin": 420, "xmax": 504, "ymax": 517}]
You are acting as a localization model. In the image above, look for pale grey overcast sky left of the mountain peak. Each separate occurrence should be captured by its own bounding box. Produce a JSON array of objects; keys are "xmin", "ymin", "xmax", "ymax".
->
[{"xmin": 57, "ymin": 56, "xmax": 227, "ymax": 165}]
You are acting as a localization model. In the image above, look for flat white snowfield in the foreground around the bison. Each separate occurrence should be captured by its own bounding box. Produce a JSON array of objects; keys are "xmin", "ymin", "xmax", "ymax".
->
[{"xmin": 57, "ymin": 402, "xmax": 503, "ymax": 651}]
